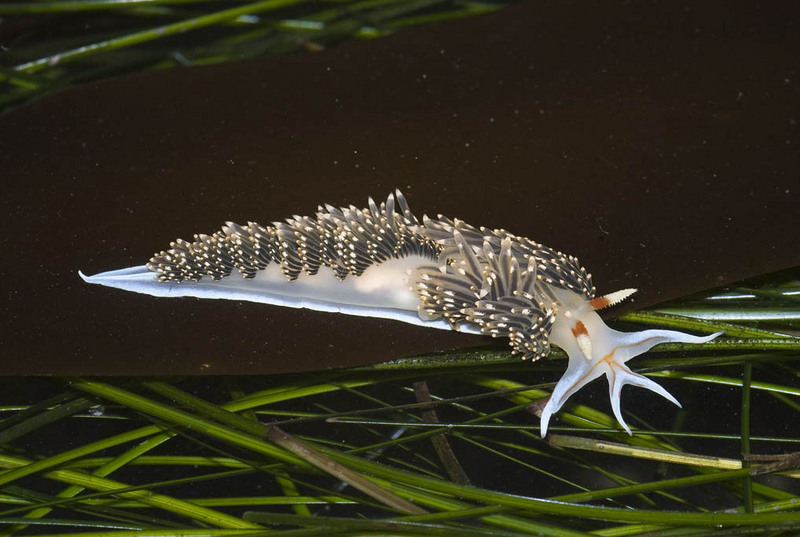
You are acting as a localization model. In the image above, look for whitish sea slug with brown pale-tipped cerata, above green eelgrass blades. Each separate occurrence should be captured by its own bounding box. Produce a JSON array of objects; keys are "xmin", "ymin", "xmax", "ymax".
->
[{"xmin": 81, "ymin": 191, "xmax": 721, "ymax": 436}]
